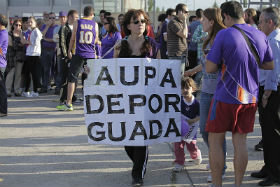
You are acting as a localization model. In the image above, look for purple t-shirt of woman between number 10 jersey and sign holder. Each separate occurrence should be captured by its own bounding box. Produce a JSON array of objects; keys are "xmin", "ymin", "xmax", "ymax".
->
[{"xmin": 101, "ymin": 32, "xmax": 122, "ymax": 59}]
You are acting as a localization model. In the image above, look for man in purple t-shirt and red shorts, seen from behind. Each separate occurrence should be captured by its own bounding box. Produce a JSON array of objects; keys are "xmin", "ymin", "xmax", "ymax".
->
[{"xmin": 206, "ymin": 1, "xmax": 273, "ymax": 187}]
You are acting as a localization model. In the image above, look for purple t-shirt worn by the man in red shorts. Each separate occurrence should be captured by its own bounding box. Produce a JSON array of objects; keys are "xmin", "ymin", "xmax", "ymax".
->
[{"xmin": 207, "ymin": 24, "xmax": 273, "ymax": 104}]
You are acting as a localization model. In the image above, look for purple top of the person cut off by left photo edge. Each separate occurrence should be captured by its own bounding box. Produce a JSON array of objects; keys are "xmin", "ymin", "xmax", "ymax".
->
[{"xmin": 0, "ymin": 29, "xmax": 8, "ymax": 68}]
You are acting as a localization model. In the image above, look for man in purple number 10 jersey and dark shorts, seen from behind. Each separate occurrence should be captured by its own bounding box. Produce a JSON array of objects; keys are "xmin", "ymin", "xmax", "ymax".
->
[{"xmin": 56, "ymin": 6, "xmax": 99, "ymax": 111}]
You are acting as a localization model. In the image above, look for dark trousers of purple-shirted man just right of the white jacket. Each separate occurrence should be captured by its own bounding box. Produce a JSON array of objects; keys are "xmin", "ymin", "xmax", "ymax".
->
[{"xmin": 41, "ymin": 49, "xmax": 55, "ymax": 89}]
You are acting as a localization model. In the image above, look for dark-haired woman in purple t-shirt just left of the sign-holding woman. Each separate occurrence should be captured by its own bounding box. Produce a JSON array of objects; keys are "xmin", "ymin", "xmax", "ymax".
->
[{"xmin": 101, "ymin": 17, "xmax": 122, "ymax": 59}]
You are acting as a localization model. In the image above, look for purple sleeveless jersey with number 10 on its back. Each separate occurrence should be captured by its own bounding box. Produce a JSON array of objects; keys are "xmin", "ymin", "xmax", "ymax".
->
[{"xmin": 75, "ymin": 18, "xmax": 96, "ymax": 59}]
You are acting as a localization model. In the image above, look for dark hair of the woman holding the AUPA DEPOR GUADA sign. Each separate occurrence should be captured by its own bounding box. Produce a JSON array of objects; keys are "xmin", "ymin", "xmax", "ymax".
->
[{"xmin": 123, "ymin": 9, "xmax": 150, "ymax": 36}]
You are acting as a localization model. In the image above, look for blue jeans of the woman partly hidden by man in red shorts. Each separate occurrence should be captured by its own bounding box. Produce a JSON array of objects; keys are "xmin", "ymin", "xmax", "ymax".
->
[{"xmin": 199, "ymin": 92, "xmax": 227, "ymax": 174}]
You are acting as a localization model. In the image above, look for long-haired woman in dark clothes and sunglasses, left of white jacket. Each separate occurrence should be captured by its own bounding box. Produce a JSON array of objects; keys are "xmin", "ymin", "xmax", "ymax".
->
[{"xmin": 6, "ymin": 20, "xmax": 25, "ymax": 97}]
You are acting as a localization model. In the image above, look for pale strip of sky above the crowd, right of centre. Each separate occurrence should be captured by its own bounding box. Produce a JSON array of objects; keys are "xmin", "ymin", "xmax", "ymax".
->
[{"xmin": 156, "ymin": 0, "xmax": 225, "ymax": 10}]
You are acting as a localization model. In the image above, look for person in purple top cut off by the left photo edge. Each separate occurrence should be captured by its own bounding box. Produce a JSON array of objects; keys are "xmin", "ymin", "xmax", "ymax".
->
[{"xmin": 0, "ymin": 14, "xmax": 8, "ymax": 117}]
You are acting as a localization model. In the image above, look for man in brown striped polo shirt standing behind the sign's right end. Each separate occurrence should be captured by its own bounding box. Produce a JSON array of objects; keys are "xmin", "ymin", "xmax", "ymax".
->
[{"xmin": 167, "ymin": 3, "xmax": 189, "ymax": 73}]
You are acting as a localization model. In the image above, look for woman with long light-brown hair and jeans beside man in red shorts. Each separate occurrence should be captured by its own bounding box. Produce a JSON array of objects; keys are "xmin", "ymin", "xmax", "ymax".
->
[{"xmin": 185, "ymin": 8, "xmax": 226, "ymax": 182}]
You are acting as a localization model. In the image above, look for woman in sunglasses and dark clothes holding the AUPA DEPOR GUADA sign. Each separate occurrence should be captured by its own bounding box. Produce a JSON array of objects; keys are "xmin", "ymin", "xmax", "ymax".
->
[{"xmin": 114, "ymin": 9, "xmax": 160, "ymax": 186}]
